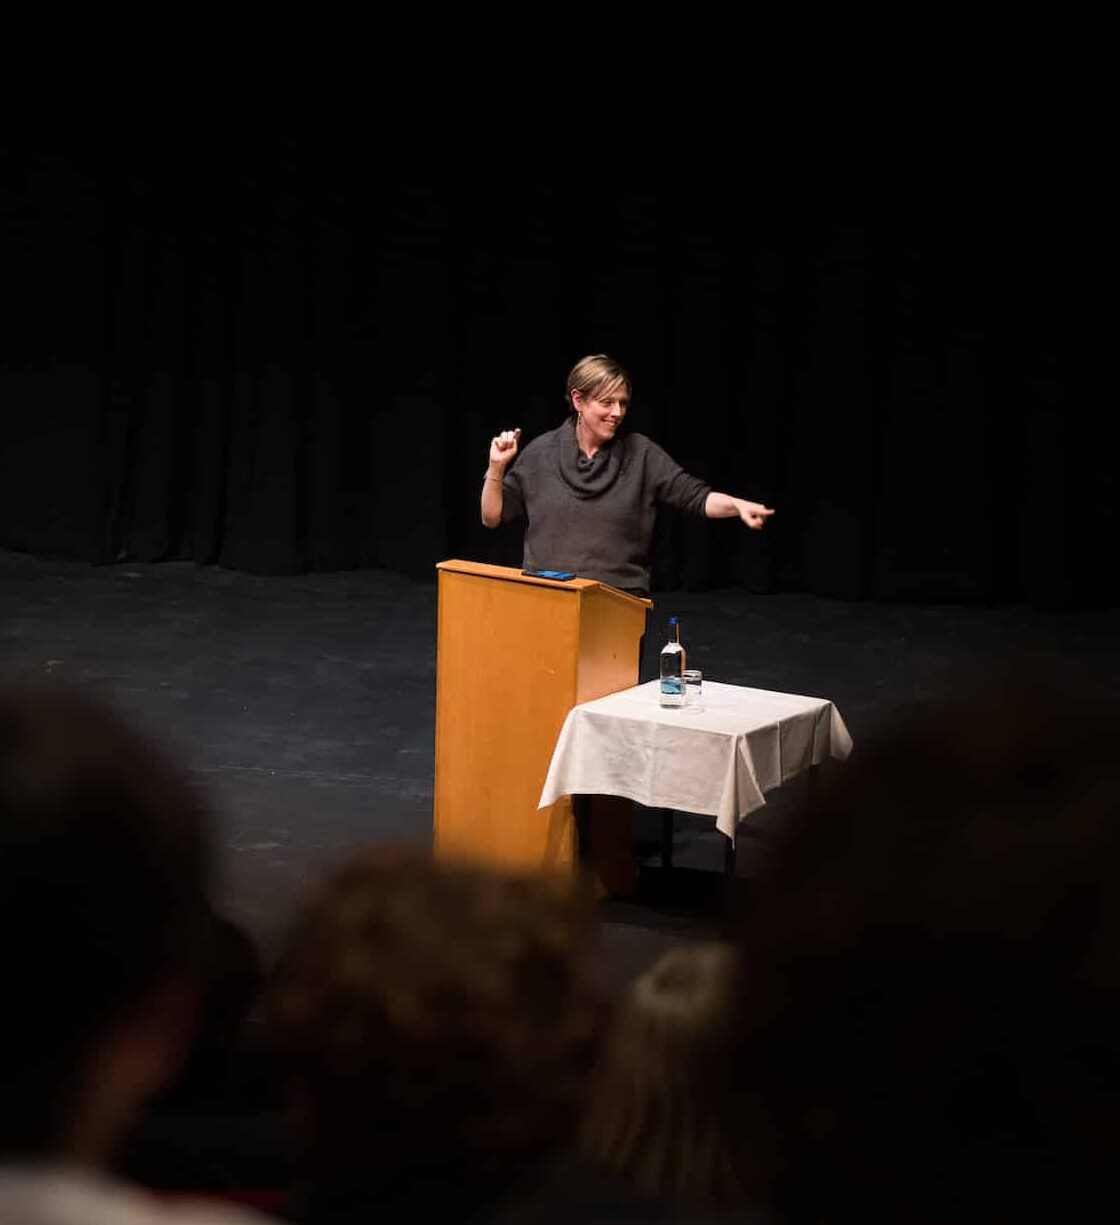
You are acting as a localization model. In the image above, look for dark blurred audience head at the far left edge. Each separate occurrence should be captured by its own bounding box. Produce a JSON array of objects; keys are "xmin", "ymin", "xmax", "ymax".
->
[{"xmin": 0, "ymin": 688, "xmax": 210, "ymax": 1161}]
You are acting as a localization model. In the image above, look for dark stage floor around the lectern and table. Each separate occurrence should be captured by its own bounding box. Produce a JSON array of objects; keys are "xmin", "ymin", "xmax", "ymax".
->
[{"xmin": 0, "ymin": 552, "xmax": 1120, "ymax": 982}]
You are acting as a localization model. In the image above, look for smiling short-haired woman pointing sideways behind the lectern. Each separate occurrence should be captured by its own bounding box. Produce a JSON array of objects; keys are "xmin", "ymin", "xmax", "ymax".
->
[{"xmin": 482, "ymin": 353, "xmax": 774, "ymax": 597}]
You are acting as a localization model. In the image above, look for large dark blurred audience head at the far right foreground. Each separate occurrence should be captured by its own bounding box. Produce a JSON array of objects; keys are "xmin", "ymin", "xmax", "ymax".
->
[{"xmin": 735, "ymin": 660, "xmax": 1120, "ymax": 1223}]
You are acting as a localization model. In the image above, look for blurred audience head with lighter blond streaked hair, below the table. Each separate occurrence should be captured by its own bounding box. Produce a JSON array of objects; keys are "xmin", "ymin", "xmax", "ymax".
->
[{"xmin": 581, "ymin": 942, "xmax": 746, "ymax": 1207}]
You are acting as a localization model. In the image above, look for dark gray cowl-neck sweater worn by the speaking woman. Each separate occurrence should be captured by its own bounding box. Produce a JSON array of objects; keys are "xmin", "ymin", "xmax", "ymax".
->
[{"xmin": 501, "ymin": 418, "xmax": 712, "ymax": 592}]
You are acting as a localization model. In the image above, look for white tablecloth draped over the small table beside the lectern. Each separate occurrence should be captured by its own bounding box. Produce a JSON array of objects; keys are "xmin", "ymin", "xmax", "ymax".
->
[{"xmin": 538, "ymin": 680, "xmax": 852, "ymax": 838}]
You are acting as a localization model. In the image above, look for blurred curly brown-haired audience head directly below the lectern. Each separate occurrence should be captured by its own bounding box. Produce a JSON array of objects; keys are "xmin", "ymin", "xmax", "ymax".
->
[{"xmin": 267, "ymin": 849, "xmax": 602, "ymax": 1215}]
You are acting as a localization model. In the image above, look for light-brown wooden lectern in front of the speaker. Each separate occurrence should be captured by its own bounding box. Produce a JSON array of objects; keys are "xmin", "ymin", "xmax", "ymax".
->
[{"xmin": 435, "ymin": 561, "xmax": 652, "ymax": 872}]
